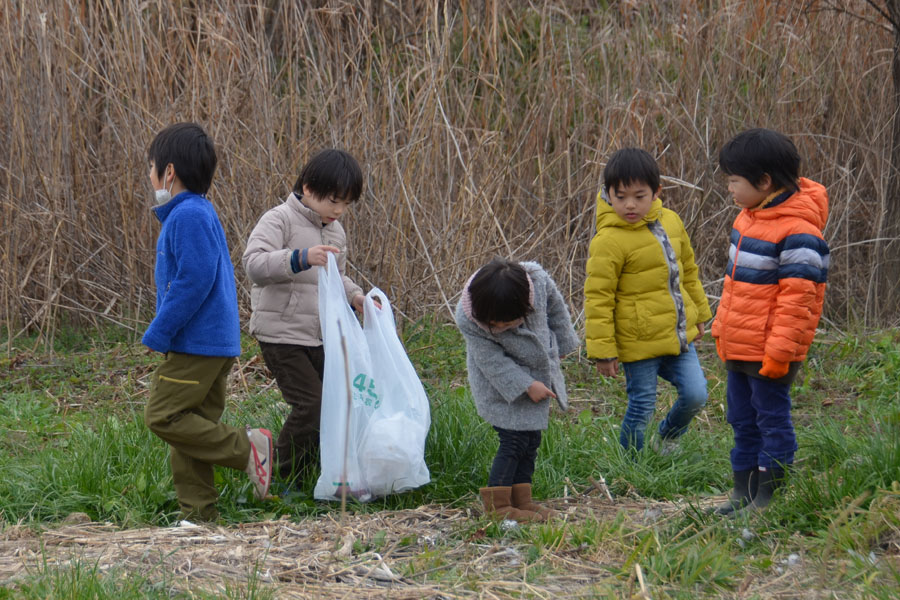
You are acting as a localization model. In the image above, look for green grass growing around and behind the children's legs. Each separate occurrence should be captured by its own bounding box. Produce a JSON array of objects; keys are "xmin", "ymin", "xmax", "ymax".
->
[{"xmin": 0, "ymin": 321, "xmax": 900, "ymax": 598}]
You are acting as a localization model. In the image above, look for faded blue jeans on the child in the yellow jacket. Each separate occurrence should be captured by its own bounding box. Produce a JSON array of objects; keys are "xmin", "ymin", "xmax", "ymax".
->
[{"xmin": 619, "ymin": 344, "xmax": 706, "ymax": 450}]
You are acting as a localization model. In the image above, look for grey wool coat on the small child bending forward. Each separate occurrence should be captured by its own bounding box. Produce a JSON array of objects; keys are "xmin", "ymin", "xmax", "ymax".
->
[{"xmin": 456, "ymin": 262, "xmax": 579, "ymax": 431}]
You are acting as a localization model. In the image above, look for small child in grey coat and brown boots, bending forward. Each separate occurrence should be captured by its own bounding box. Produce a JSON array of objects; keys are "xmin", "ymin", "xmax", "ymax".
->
[{"xmin": 456, "ymin": 259, "xmax": 579, "ymax": 521}]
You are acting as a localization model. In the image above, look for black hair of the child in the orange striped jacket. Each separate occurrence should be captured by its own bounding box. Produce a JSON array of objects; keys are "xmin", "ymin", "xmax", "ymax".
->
[{"xmin": 719, "ymin": 128, "xmax": 800, "ymax": 192}]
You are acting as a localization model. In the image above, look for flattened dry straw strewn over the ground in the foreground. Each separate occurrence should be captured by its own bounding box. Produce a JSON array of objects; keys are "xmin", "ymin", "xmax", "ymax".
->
[{"xmin": 0, "ymin": 492, "xmax": 876, "ymax": 600}]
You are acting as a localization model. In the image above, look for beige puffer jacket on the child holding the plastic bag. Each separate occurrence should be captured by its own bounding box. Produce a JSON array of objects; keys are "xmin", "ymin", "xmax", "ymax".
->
[{"xmin": 242, "ymin": 193, "xmax": 363, "ymax": 346}]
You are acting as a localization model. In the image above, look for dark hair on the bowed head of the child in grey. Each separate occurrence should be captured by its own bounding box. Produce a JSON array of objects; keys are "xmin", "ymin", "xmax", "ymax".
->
[{"xmin": 469, "ymin": 258, "xmax": 533, "ymax": 324}]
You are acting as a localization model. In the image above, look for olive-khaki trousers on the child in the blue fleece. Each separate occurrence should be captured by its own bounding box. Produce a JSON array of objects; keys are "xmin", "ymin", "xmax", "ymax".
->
[{"xmin": 144, "ymin": 352, "xmax": 250, "ymax": 521}]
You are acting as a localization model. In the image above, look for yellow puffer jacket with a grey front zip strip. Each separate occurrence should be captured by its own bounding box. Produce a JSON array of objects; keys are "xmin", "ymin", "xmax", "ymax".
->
[{"xmin": 584, "ymin": 194, "xmax": 712, "ymax": 362}]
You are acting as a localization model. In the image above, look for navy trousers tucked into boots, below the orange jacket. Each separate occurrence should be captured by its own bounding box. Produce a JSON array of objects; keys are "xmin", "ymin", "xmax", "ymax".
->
[{"xmin": 726, "ymin": 371, "xmax": 797, "ymax": 471}]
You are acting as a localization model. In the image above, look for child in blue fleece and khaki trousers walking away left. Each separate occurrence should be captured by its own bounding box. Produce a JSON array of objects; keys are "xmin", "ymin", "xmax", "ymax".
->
[{"xmin": 143, "ymin": 123, "xmax": 272, "ymax": 521}]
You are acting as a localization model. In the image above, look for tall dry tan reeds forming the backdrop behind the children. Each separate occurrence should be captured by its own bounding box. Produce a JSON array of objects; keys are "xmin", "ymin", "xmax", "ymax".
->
[{"xmin": 0, "ymin": 0, "xmax": 892, "ymax": 350}]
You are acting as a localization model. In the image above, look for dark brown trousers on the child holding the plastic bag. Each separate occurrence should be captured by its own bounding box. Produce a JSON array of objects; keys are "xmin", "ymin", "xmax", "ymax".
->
[{"xmin": 259, "ymin": 342, "xmax": 325, "ymax": 479}]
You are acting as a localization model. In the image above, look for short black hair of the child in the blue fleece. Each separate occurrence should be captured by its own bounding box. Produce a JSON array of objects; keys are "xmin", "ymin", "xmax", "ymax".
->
[{"xmin": 147, "ymin": 123, "xmax": 217, "ymax": 194}]
